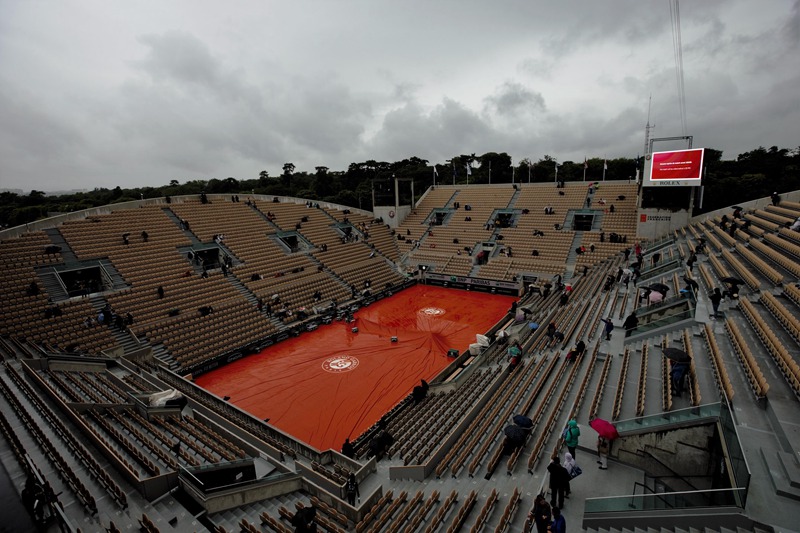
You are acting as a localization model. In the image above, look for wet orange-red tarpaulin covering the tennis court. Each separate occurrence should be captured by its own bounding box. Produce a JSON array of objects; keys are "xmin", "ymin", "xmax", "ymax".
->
[{"xmin": 196, "ymin": 285, "xmax": 514, "ymax": 450}]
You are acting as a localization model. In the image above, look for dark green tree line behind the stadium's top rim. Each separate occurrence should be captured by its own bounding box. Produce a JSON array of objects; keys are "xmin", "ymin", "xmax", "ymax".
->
[{"xmin": 0, "ymin": 146, "xmax": 800, "ymax": 227}]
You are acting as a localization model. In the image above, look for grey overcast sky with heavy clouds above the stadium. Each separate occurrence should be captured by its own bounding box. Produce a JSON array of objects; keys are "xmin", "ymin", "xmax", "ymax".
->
[{"xmin": 0, "ymin": 0, "xmax": 800, "ymax": 191}]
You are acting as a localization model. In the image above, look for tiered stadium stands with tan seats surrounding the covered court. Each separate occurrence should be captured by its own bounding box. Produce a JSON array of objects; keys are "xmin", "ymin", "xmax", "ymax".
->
[{"xmin": 0, "ymin": 182, "xmax": 800, "ymax": 532}]
